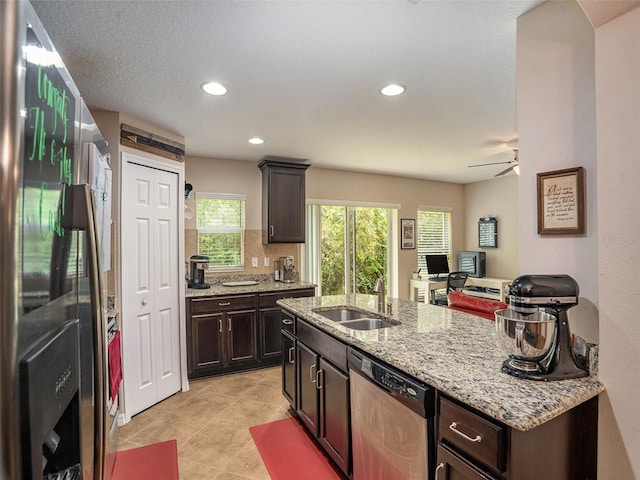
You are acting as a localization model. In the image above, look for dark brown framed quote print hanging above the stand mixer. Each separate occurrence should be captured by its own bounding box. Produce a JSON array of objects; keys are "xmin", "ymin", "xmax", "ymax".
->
[{"xmin": 538, "ymin": 167, "xmax": 585, "ymax": 235}]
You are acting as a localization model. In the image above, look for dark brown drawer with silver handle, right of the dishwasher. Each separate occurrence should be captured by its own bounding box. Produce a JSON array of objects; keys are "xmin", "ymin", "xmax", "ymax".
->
[{"xmin": 438, "ymin": 397, "xmax": 506, "ymax": 472}]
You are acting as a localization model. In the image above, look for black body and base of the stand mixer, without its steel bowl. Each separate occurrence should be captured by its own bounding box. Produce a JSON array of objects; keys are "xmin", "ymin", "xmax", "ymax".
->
[{"xmin": 496, "ymin": 275, "xmax": 588, "ymax": 381}]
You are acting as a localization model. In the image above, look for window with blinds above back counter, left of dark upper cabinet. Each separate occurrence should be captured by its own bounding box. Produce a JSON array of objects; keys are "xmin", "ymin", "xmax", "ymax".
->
[{"xmin": 196, "ymin": 193, "xmax": 246, "ymax": 270}]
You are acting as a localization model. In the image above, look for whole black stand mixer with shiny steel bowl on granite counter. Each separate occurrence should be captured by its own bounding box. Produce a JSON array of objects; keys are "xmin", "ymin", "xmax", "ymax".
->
[{"xmin": 495, "ymin": 275, "xmax": 588, "ymax": 381}]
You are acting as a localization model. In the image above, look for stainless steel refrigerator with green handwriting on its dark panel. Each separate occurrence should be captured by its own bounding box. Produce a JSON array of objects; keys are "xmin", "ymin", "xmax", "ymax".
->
[{"xmin": 0, "ymin": 1, "xmax": 119, "ymax": 480}]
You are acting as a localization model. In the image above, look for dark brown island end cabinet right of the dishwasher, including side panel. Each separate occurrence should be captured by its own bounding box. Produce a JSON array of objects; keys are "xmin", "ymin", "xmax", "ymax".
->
[{"xmin": 435, "ymin": 396, "xmax": 598, "ymax": 480}]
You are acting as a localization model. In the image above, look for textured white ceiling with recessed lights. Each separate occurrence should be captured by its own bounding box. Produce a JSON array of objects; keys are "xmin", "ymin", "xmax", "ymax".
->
[{"xmin": 32, "ymin": 0, "xmax": 540, "ymax": 183}]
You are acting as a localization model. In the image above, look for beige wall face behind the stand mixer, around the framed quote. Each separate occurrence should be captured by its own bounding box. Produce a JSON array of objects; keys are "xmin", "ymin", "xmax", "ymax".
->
[{"xmin": 517, "ymin": 1, "xmax": 598, "ymax": 341}]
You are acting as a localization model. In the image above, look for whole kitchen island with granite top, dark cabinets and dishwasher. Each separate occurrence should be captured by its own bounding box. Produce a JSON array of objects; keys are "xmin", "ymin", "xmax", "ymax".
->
[{"xmin": 277, "ymin": 295, "xmax": 604, "ymax": 480}]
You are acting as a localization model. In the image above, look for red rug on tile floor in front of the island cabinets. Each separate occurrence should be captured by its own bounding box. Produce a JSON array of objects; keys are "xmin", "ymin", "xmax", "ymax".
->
[{"xmin": 249, "ymin": 418, "xmax": 345, "ymax": 480}]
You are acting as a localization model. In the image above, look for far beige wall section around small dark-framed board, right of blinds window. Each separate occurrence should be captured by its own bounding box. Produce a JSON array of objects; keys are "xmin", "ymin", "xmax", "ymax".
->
[{"xmin": 464, "ymin": 173, "xmax": 520, "ymax": 279}]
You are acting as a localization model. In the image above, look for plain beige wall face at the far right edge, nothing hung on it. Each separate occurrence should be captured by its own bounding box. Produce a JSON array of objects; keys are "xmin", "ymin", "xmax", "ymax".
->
[{"xmin": 595, "ymin": 8, "xmax": 640, "ymax": 479}]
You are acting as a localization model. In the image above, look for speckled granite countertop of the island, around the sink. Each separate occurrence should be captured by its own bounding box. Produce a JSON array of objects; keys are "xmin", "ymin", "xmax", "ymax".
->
[{"xmin": 278, "ymin": 295, "xmax": 604, "ymax": 431}]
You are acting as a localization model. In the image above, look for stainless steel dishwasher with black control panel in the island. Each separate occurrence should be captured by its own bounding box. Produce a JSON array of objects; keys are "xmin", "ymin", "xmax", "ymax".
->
[{"xmin": 348, "ymin": 348, "xmax": 435, "ymax": 480}]
